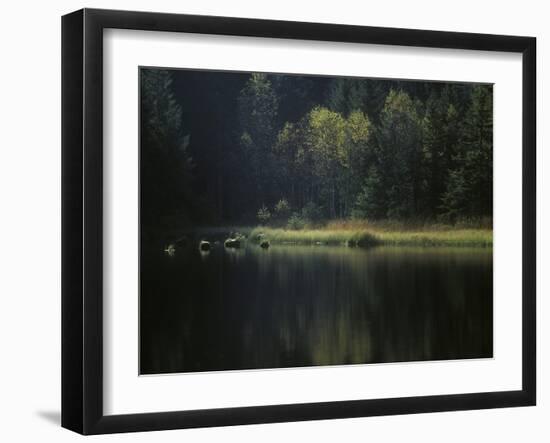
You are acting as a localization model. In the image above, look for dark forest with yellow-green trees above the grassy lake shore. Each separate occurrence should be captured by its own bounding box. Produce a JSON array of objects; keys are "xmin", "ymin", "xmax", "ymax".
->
[{"xmin": 140, "ymin": 68, "xmax": 493, "ymax": 243}]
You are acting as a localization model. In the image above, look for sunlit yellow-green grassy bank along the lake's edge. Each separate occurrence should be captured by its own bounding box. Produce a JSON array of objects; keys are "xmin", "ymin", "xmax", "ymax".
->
[{"xmin": 249, "ymin": 222, "xmax": 493, "ymax": 247}]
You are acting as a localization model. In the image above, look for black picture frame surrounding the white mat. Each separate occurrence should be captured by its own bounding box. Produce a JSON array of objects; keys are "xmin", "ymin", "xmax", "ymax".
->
[{"xmin": 62, "ymin": 9, "xmax": 536, "ymax": 434}]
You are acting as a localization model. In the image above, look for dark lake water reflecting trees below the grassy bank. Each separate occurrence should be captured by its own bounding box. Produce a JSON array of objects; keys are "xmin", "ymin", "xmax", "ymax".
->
[{"xmin": 140, "ymin": 244, "xmax": 493, "ymax": 374}]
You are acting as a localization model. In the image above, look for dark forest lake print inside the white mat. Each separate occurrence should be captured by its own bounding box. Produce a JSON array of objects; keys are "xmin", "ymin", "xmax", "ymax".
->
[{"xmin": 139, "ymin": 67, "xmax": 493, "ymax": 375}]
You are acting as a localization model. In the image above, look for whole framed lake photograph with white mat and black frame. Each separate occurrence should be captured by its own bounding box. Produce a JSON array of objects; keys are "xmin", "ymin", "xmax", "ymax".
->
[{"xmin": 62, "ymin": 9, "xmax": 536, "ymax": 434}]
